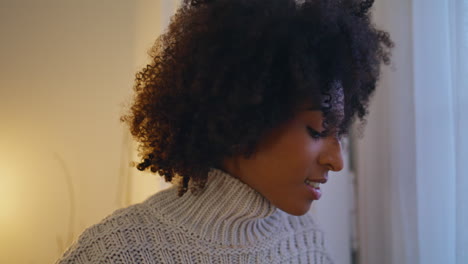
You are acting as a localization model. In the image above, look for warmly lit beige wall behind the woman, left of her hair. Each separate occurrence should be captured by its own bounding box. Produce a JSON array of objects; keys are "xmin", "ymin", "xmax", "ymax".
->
[{"xmin": 0, "ymin": 0, "xmax": 174, "ymax": 263}]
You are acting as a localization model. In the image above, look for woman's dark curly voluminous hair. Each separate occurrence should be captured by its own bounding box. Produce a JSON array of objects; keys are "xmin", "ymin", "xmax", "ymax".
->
[{"xmin": 122, "ymin": 0, "xmax": 393, "ymax": 195}]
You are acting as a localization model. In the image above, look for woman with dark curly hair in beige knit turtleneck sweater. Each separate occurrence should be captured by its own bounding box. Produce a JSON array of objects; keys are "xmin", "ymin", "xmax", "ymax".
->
[{"xmin": 59, "ymin": 0, "xmax": 393, "ymax": 263}]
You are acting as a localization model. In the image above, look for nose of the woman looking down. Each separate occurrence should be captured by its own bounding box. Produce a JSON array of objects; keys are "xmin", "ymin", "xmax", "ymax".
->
[{"xmin": 318, "ymin": 136, "xmax": 343, "ymax": 171}]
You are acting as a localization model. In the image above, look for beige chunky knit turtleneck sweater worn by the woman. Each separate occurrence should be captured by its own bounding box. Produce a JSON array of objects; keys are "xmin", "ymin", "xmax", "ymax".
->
[{"xmin": 57, "ymin": 169, "xmax": 332, "ymax": 264}]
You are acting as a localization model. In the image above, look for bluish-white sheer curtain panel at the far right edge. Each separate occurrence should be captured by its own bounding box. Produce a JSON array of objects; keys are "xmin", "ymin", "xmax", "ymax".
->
[{"xmin": 413, "ymin": 0, "xmax": 468, "ymax": 264}]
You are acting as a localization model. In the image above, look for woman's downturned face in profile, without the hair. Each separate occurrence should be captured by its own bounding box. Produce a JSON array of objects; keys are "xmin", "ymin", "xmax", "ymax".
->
[{"xmin": 224, "ymin": 110, "xmax": 343, "ymax": 215}]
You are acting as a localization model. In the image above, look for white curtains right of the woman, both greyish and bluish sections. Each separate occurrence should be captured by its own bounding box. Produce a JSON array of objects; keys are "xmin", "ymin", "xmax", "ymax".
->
[{"xmin": 354, "ymin": 0, "xmax": 468, "ymax": 264}]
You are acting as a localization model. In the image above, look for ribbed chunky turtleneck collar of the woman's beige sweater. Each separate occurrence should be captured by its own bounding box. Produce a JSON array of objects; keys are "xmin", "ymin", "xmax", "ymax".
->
[{"xmin": 151, "ymin": 169, "xmax": 285, "ymax": 246}]
